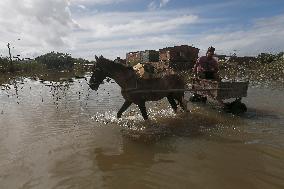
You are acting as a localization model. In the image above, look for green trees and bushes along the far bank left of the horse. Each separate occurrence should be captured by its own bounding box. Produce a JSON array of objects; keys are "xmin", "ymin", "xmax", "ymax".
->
[{"xmin": 0, "ymin": 52, "xmax": 93, "ymax": 85}]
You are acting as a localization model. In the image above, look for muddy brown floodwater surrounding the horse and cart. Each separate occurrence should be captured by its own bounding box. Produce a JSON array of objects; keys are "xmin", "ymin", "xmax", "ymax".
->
[{"xmin": 0, "ymin": 74, "xmax": 284, "ymax": 189}]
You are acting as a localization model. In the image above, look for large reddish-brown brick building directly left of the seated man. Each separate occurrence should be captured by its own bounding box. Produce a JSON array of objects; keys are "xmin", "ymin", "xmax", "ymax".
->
[{"xmin": 159, "ymin": 45, "xmax": 199, "ymax": 70}]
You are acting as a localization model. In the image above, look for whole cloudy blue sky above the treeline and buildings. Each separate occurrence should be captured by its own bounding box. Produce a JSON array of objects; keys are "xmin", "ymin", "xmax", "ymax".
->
[{"xmin": 0, "ymin": 0, "xmax": 284, "ymax": 60}]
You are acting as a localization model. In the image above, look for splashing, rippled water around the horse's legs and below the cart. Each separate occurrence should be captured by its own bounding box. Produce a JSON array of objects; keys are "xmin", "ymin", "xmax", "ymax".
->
[{"xmin": 91, "ymin": 104, "xmax": 245, "ymax": 141}]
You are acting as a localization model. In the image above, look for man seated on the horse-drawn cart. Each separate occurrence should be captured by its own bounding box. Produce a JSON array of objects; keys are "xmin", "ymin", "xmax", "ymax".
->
[{"xmin": 193, "ymin": 47, "xmax": 219, "ymax": 80}]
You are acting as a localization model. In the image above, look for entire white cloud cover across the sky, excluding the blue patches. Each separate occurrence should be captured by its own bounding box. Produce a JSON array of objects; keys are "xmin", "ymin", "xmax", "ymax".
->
[{"xmin": 0, "ymin": 0, "xmax": 284, "ymax": 59}]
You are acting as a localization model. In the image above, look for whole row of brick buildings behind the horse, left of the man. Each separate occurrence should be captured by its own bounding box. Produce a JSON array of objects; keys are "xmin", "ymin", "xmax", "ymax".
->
[{"xmin": 126, "ymin": 45, "xmax": 199, "ymax": 70}]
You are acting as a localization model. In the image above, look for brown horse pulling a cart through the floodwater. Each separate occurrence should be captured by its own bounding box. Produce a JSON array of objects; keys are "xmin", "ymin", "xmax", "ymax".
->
[{"xmin": 89, "ymin": 56, "xmax": 186, "ymax": 120}]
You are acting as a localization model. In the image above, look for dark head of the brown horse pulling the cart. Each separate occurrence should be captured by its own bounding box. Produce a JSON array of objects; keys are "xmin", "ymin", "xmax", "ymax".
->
[{"xmin": 89, "ymin": 56, "xmax": 107, "ymax": 90}]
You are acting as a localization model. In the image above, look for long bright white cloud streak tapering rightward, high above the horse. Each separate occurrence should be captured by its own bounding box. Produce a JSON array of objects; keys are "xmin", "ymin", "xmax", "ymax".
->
[{"xmin": 78, "ymin": 13, "xmax": 198, "ymax": 38}]
